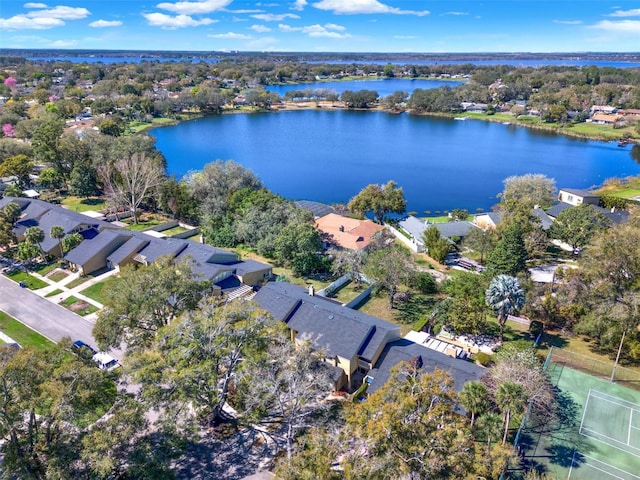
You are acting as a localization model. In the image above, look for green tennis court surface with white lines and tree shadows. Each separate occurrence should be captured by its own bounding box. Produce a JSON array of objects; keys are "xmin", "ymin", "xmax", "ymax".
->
[{"xmin": 520, "ymin": 363, "xmax": 640, "ymax": 480}]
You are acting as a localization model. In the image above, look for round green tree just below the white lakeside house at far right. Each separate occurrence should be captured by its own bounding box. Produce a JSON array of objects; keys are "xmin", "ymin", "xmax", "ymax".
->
[{"xmin": 549, "ymin": 205, "xmax": 611, "ymax": 250}]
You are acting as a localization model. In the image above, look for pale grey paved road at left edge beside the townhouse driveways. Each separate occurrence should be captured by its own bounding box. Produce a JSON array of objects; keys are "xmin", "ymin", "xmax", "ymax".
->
[{"xmin": 0, "ymin": 275, "xmax": 96, "ymax": 346}]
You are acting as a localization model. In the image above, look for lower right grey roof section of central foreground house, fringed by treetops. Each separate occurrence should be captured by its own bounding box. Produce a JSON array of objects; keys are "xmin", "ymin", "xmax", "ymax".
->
[{"xmin": 367, "ymin": 339, "xmax": 486, "ymax": 393}]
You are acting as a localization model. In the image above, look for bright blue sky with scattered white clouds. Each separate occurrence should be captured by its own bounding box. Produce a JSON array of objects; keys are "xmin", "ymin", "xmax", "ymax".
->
[{"xmin": 0, "ymin": 0, "xmax": 640, "ymax": 53}]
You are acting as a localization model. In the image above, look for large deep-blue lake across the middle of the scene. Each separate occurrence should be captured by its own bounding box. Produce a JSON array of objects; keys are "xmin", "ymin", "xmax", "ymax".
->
[{"xmin": 152, "ymin": 110, "xmax": 640, "ymax": 214}]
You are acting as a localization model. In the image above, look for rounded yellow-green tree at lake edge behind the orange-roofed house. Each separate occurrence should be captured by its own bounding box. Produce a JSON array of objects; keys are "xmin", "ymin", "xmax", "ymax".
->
[{"xmin": 348, "ymin": 180, "xmax": 407, "ymax": 225}]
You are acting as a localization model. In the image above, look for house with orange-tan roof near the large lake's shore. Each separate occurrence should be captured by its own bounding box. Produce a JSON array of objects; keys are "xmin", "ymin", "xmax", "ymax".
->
[{"xmin": 316, "ymin": 213, "xmax": 384, "ymax": 250}]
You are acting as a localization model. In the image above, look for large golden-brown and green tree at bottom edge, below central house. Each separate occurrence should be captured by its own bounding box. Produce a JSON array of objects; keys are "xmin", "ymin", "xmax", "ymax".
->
[{"xmin": 345, "ymin": 361, "xmax": 474, "ymax": 479}]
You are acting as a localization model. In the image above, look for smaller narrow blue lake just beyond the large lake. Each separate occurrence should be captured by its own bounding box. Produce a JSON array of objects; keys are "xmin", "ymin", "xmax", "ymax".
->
[{"xmin": 264, "ymin": 78, "xmax": 464, "ymax": 98}]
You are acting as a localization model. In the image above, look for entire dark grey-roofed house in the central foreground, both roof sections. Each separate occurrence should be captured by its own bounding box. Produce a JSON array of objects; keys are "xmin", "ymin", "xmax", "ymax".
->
[{"xmin": 254, "ymin": 282, "xmax": 486, "ymax": 392}]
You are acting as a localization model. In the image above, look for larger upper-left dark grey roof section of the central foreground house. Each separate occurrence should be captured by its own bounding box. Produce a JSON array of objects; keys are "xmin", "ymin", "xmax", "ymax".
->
[{"xmin": 254, "ymin": 282, "xmax": 400, "ymax": 360}]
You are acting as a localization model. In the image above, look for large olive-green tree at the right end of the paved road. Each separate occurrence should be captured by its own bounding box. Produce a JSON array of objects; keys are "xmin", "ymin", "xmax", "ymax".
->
[{"xmin": 93, "ymin": 257, "xmax": 208, "ymax": 352}]
